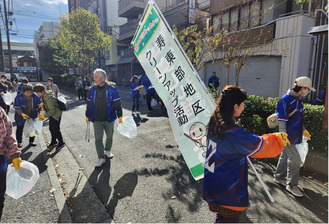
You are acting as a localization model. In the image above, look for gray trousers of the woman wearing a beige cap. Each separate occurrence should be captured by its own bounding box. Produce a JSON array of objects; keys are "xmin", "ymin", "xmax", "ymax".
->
[{"xmin": 274, "ymin": 145, "xmax": 301, "ymax": 186}]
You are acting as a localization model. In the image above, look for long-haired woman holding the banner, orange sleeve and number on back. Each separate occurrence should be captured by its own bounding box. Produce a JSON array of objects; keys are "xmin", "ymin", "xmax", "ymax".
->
[{"xmin": 203, "ymin": 86, "xmax": 290, "ymax": 223}]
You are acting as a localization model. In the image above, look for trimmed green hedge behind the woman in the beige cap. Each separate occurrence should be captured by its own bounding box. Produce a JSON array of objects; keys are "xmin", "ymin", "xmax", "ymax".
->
[{"xmin": 238, "ymin": 96, "xmax": 328, "ymax": 153}]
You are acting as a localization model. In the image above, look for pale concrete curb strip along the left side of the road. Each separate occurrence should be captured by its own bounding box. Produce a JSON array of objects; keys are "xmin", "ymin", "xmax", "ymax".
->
[{"xmin": 39, "ymin": 134, "xmax": 72, "ymax": 223}]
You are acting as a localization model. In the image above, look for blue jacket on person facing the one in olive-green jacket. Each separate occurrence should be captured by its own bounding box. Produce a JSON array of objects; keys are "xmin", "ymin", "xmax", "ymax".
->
[{"xmin": 14, "ymin": 93, "xmax": 42, "ymax": 125}]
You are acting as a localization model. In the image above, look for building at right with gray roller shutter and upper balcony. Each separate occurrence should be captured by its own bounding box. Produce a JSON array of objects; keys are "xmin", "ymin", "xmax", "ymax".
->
[{"xmin": 199, "ymin": 0, "xmax": 328, "ymax": 97}]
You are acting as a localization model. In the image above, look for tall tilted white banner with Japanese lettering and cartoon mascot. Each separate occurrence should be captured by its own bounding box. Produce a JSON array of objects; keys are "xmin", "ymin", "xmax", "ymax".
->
[{"xmin": 132, "ymin": 1, "xmax": 215, "ymax": 180}]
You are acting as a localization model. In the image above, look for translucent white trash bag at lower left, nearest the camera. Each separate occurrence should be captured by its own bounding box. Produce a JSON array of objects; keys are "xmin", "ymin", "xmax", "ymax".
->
[{"xmin": 6, "ymin": 160, "xmax": 39, "ymax": 199}]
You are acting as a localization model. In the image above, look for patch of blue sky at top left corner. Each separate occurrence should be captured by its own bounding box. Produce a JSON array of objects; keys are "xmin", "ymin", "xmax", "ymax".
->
[{"xmin": 0, "ymin": 0, "xmax": 68, "ymax": 43}]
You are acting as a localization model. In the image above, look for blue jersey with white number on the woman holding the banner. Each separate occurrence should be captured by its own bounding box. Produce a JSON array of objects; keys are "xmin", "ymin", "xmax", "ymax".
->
[{"xmin": 203, "ymin": 126, "xmax": 263, "ymax": 207}]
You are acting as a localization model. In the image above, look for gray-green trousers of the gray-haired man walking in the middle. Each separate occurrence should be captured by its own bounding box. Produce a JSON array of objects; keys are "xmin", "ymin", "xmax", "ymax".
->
[{"xmin": 93, "ymin": 121, "xmax": 114, "ymax": 159}]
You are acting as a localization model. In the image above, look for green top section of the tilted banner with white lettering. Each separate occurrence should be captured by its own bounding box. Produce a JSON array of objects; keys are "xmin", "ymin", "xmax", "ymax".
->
[{"xmin": 133, "ymin": 5, "xmax": 162, "ymax": 57}]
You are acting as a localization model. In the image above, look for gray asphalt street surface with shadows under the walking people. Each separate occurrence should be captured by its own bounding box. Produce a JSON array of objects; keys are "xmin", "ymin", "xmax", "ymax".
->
[{"xmin": 1, "ymin": 87, "xmax": 328, "ymax": 223}]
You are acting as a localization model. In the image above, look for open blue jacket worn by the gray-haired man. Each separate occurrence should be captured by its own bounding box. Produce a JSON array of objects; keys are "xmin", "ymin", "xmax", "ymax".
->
[{"xmin": 87, "ymin": 85, "xmax": 121, "ymax": 122}]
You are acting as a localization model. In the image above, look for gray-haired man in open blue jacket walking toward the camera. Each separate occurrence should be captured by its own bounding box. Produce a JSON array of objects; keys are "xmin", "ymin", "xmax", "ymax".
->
[{"xmin": 86, "ymin": 69, "xmax": 122, "ymax": 167}]
